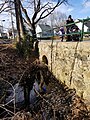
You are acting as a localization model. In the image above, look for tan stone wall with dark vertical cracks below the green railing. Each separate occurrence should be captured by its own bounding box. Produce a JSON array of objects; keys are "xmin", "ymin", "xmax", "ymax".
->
[{"xmin": 39, "ymin": 41, "xmax": 90, "ymax": 104}]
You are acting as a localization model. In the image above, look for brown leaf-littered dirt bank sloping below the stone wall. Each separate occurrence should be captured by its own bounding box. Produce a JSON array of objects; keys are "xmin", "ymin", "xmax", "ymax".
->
[{"xmin": 0, "ymin": 44, "xmax": 90, "ymax": 120}]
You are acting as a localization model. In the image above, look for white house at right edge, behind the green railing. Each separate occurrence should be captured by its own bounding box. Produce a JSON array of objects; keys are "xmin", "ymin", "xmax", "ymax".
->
[{"xmin": 75, "ymin": 19, "xmax": 90, "ymax": 32}]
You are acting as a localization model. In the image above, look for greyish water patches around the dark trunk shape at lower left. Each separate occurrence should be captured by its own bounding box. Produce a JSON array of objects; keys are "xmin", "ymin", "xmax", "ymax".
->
[{"xmin": 6, "ymin": 82, "xmax": 39, "ymax": 104}]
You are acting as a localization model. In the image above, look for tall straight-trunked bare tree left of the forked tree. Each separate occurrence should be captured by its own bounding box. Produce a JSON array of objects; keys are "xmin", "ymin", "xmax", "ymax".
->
[{"xmin": 0, "ymin": 0, "xmax": 24, "ymax": 40}]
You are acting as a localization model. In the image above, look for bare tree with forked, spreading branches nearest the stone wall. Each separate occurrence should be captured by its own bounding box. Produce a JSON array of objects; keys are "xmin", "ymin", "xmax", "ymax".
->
[{"xmin": 21, "ymin": 0, "xmax": 68, "ymax": 40}]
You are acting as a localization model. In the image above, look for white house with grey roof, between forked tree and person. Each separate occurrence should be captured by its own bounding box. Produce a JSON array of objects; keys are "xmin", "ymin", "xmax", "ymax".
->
[{"xmin": 36, "ymin": 24, "xmax": 54, "ymax": 38}]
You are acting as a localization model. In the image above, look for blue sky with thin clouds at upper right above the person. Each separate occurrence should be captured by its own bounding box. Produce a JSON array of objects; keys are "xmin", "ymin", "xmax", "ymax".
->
[{"xmin": 55, "ymin": 0, "xmax": 90, "ymax": 19}]
